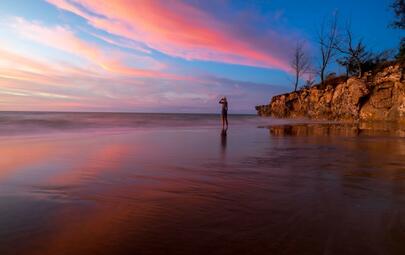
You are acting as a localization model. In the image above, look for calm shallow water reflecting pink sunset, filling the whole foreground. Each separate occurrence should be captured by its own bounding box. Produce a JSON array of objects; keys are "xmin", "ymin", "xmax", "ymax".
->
[{"xmin": 0, "ymin": 113, "xmax": 405, "ymax": 255}]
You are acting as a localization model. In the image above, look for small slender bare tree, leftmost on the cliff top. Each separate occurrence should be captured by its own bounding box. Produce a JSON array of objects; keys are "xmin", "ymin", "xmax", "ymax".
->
[{"xmin": 291, "ymin": 41, "xmax": 310, "ymax": 91}]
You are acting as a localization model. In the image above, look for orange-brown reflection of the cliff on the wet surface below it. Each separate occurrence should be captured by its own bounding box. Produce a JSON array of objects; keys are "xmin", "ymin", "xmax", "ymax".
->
[{"xmin": 268, "ymin": 123, "xmax": 405, "ymax": 179}]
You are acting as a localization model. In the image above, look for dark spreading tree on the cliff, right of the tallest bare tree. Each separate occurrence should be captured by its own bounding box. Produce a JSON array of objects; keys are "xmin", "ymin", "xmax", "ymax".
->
[{"xmin": 335, "ymin": 25, "xmax": 370, "ymax": 78}]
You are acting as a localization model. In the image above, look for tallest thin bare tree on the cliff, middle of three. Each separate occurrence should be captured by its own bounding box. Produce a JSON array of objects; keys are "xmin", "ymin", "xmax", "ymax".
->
[{"xmin": 318, "ymin": 14, "xmax": 338, "ymax": 85}]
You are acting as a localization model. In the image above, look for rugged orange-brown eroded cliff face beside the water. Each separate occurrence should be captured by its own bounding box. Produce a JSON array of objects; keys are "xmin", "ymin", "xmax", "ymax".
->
[{"xmin": 256, "ymin": 65, "xmax": 405, "ymax": 122}]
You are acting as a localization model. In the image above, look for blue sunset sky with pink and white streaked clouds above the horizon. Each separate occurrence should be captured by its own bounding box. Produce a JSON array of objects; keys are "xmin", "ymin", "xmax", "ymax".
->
[{"xmin": 0, "ymin": 0, "xmax": 403, "ymax": 113}]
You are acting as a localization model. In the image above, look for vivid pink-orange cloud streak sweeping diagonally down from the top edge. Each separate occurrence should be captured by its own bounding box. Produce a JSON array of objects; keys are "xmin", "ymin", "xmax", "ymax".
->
[{"xmin": 47, "ymin": 0, "xmax": 290, "ymax": 71}]
